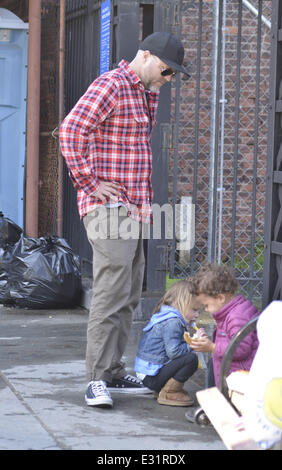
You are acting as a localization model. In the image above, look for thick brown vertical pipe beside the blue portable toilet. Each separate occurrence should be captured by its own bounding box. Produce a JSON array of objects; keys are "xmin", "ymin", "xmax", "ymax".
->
[{"xmin": 25, "ymin": 0, "xmax": 41, "ymax": 238}]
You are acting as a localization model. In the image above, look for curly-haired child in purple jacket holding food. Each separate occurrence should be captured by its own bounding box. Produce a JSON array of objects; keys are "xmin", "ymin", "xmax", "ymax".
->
[{"xmin": 188, "ymin": 264, "xmax": 259, "ymax": 387}]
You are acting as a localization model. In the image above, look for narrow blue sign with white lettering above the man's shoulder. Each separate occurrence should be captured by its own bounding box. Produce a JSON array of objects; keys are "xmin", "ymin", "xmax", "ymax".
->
[{"xmin": 100, "ymin": 0, "xmax": 111, "ymax": 75}]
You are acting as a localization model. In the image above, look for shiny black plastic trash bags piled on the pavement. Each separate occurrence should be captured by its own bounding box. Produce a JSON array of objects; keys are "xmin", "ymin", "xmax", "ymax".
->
[{"xmin": 0, "ymin": 212, "xmax": 81, "ymax": 309}]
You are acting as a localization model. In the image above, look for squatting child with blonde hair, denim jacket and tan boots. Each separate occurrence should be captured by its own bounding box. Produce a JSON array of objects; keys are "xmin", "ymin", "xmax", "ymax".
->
[{"xmin": 134, "ymin": 280, "xmax": 198, "ymax": 406}]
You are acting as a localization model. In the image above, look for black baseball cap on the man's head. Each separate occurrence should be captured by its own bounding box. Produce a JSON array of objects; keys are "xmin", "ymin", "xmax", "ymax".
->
[{"xmin": 139, "ymin": 31, "xmax": 190, "ymax": 77}]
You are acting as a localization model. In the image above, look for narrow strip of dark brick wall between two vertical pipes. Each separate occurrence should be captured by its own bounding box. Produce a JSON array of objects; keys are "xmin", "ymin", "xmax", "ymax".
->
[{"xmin": 39, "ymin": 0, "xmax": 59, "ymax": 235}]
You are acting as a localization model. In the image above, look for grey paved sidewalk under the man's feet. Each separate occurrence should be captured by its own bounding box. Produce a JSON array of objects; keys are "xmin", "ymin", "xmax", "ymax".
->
[{"xmin": 0, "ymin": 305, "xmax": 225, "ymax": 451}]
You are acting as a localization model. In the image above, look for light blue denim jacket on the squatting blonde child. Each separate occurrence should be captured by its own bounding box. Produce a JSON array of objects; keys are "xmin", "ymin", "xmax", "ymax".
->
[{"xmin": 134, "ymin": 305, "xmax": 190, "ymax": 375}]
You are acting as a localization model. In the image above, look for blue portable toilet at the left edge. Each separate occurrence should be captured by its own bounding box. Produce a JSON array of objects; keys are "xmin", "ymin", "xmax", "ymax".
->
[{"xmin": 0, "ymin": 8, "xmax": 28, "ymax": 228}]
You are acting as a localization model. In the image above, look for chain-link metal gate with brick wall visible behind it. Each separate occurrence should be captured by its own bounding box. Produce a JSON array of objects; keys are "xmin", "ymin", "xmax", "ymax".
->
[{"xmin": 170, "ymin": 0, "xmax": 272, "ymax": 305}]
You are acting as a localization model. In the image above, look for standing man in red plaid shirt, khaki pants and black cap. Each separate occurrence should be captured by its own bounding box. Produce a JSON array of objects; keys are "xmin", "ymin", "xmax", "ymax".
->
[{"xmin": 60, "ymin": 32, "xmax": 191, "ymax": 407}]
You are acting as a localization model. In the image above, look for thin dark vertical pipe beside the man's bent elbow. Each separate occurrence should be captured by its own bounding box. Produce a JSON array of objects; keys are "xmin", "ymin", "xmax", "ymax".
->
[{"xmin": 57, "ymin": 0, "xmax": 66, "ymax": 237}]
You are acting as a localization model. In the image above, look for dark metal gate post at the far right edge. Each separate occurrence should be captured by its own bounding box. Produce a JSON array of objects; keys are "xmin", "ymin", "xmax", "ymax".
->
[{"xmin": 263, "ymin": 0, "xmax": 282, "ymax": 306}]
